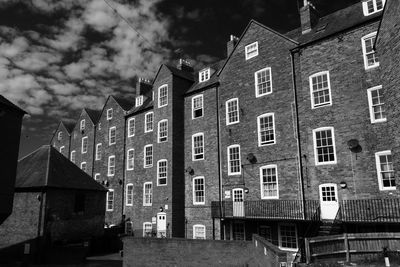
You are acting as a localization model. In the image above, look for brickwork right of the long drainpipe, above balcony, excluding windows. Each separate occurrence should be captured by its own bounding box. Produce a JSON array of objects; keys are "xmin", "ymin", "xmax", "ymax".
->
[{"xmin": 297, "ymin": 22, "xmax": 396, "ymax": 199}]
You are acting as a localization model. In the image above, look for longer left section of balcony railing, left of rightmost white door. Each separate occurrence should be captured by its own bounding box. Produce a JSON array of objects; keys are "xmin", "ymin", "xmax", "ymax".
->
[{"xmin": 211, "ymin": 200, "xmax": 319, "ymax": 220}]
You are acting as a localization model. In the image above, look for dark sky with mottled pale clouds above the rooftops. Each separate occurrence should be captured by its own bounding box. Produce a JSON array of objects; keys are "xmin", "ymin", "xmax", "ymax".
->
[{"xmin": 0, "ymin": 0, "xmax": 360, "ymax": 157}]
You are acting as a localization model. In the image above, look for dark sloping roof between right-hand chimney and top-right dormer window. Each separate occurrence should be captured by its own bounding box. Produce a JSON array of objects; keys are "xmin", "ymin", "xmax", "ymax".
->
[{"xmin": 285, "ymin": 1, "xmax": 382, "ymax": 46}]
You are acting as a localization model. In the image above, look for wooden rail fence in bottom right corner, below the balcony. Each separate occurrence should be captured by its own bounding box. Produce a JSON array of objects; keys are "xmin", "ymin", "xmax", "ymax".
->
[{"xmin": 305, "ymin": 233, "xmax": 400, "ymax": 263}]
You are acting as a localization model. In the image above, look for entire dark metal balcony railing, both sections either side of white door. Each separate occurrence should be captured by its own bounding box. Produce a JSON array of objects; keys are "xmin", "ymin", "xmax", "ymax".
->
[{"xmin": 211, "ymin": 198, "xmax": 400, "ymax": 223}]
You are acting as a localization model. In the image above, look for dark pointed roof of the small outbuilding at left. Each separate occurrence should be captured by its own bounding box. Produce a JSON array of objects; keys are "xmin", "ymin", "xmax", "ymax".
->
[{"xmin": 15, "ymin": 145, "xmax": 106, "ymax": 191}]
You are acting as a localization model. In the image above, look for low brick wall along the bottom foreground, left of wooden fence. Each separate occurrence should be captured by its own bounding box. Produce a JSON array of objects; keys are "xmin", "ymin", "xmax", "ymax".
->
[{"xmin": 123, "ymin": 236, "xmax": 289, "ymax": 267}]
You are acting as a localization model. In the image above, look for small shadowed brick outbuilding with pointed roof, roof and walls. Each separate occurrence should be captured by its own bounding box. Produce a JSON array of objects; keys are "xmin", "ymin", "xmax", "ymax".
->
[{"xmin": 0, "ymin": 145, "xmax": 107, "ymax": 262}]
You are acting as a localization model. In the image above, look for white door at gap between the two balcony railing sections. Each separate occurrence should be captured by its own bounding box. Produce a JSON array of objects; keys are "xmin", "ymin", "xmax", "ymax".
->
[{"xmin": 319, "ymin": 184, "xmax": 339, "ymax": 220}]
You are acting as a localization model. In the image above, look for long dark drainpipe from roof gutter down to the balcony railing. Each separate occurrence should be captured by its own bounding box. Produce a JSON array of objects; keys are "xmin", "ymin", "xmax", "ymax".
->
[{"xmin": 290, "ymin": 50, "xmax": 307, "ymax": 220}]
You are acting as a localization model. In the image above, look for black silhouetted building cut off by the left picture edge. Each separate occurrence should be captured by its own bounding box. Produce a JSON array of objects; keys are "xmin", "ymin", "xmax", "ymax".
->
[{"xmin": 0, "ymin": 95, "xmax": 26, "ymax": 225}]
